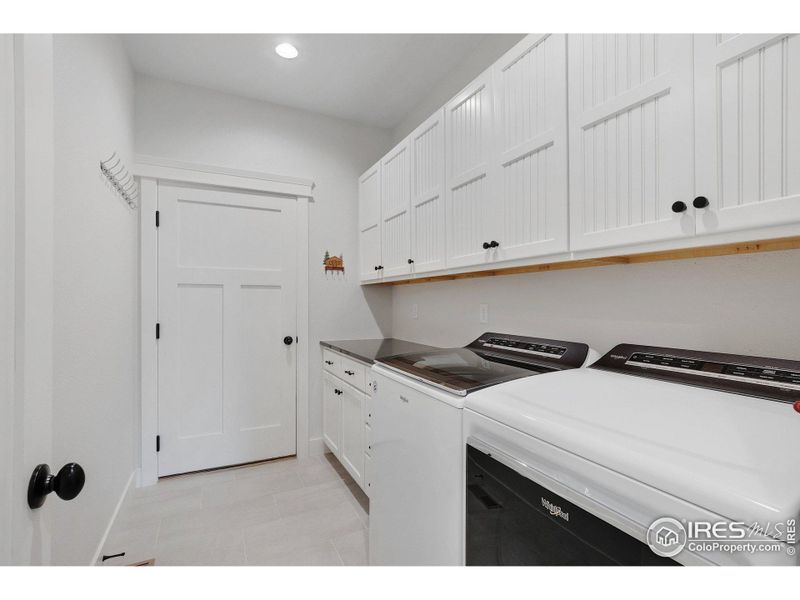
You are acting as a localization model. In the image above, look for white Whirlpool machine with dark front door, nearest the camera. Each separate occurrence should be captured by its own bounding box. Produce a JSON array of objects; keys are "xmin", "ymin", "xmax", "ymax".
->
[{"xmin": 464, "ymin": 344, "xmax": 800, "ymax": 565}]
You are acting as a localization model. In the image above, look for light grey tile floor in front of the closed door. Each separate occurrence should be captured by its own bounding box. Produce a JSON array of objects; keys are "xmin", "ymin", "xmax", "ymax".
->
[{"xmin": 103, "ymin": 454, "xmax": 369, "ymax": 565}]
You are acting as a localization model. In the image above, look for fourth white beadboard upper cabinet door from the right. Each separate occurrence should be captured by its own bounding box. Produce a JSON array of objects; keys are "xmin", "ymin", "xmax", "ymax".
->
[{"xmin": 445, "ymin": 69, "xmax": 499, "ymax": 267}]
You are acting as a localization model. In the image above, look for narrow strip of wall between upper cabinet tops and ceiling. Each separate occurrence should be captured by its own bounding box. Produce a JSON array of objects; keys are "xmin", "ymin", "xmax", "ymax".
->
[{"xmin": 390, "ymin": 34, "xmax": 525, "ymax": 144}]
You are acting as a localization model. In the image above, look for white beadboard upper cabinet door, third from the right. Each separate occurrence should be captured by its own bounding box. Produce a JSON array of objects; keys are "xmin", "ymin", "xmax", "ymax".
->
[{"xmin": 493, "ymin": 34, "xmax": 568, "ymax": 260}]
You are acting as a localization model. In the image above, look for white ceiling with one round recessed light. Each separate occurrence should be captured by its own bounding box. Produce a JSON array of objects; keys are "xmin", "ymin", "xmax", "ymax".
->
[{"xmin": 123, "ymin": 34, "xmax": 511, "ymax": 128}]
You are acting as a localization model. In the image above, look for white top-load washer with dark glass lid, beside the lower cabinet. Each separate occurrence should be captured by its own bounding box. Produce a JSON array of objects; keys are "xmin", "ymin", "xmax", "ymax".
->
[{"xmin": 369, "ymin": 333, "xmax": 596, "ymax": 565}]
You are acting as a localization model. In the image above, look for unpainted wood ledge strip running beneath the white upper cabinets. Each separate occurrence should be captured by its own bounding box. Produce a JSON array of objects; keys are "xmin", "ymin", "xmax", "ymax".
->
[{"xmin": 377, "ymin": 236, "xmax": 800, "ymax": 285}]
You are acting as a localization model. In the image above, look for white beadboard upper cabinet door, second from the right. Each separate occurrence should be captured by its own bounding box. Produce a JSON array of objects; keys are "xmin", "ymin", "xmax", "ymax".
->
[{"xmin": 568, "ymin": 34, "xmax": 695, "ymax": 250}]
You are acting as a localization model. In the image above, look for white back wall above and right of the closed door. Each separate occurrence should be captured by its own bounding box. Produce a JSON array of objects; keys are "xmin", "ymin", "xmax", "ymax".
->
[{"xmin": 135, "ymin": 76, "xmax": 391, "ymax": 450}]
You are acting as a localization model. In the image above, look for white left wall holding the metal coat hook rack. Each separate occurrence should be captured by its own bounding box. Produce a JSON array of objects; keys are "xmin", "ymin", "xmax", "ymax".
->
[{"xmin": 50, "ymin": 35, "xmax": 138, "ymax": 564}]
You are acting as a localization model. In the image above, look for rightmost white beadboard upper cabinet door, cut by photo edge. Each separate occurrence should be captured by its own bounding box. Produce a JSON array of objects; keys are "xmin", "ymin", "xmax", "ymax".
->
[{"xmin": 695, "ymin": 34, "xmax": 800, "ymax": 233}]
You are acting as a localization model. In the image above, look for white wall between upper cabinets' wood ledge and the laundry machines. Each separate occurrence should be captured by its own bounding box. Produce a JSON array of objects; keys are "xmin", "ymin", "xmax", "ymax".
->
[{"xmin": 393, "ymin": 251, "xmax": 800, "ymax": 360}]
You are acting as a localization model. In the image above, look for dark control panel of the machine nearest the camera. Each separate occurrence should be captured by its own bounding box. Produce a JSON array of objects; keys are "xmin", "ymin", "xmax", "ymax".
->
[{"xmin": 592, "ymin": 344, "xmax": 800, "ymax": 403}]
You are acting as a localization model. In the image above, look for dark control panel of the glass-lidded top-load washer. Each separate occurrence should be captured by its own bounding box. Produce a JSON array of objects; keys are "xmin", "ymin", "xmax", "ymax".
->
[{"xmin": 467, "ymin": 332, "xmax": 589, "ymax": 368}]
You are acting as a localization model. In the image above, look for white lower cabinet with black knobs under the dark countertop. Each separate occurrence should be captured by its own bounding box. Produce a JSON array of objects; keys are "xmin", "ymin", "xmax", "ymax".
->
[{"xmin": 322, "ymin": 349, "xmax": 371, "ymax": 495}]
